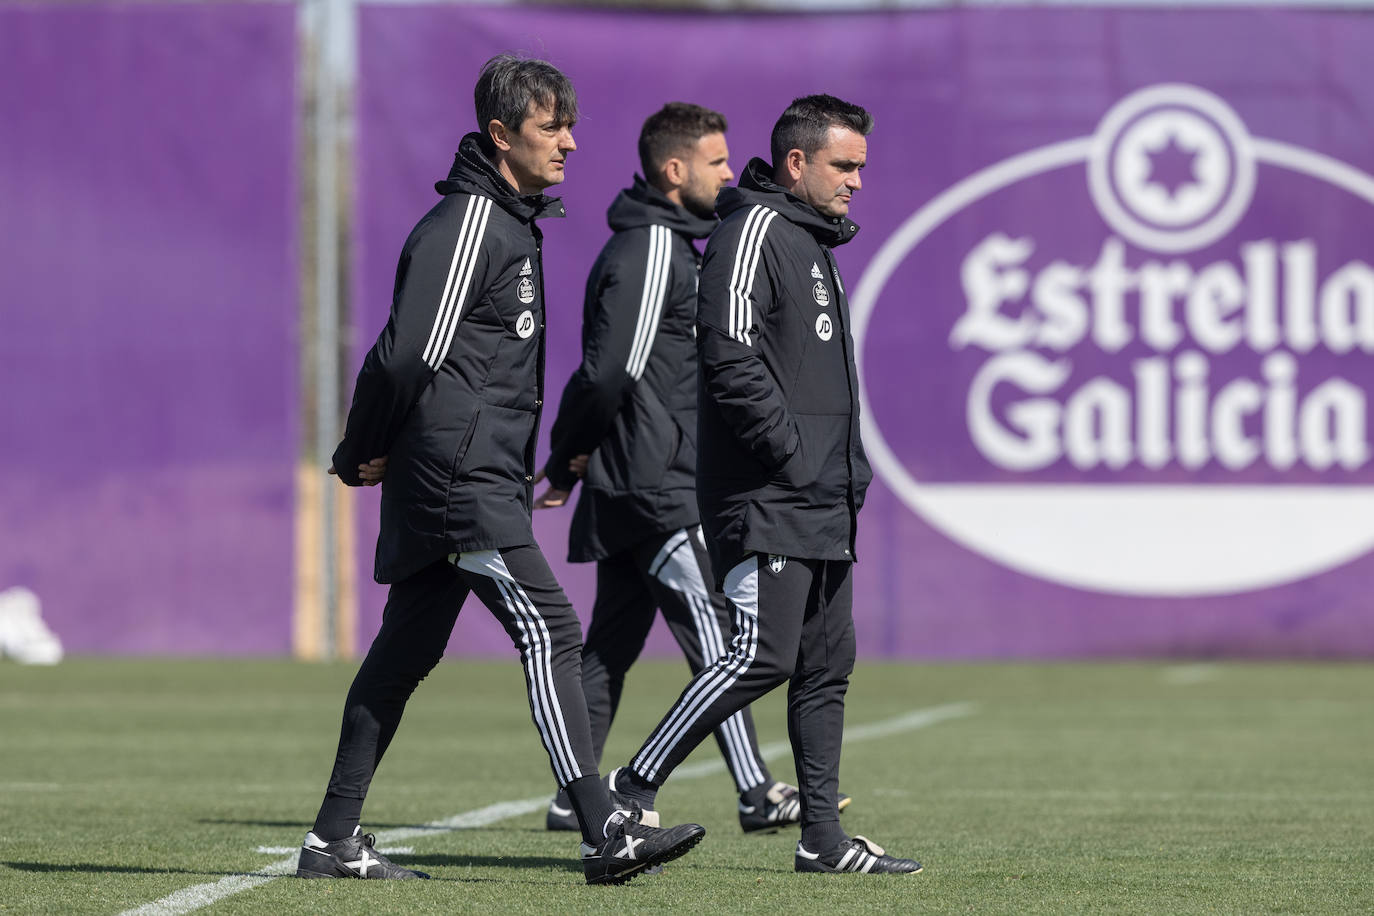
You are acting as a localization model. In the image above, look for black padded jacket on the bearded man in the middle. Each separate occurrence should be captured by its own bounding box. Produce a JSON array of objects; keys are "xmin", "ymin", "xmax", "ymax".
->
[{"xmin": 545, "ymin": 176, "xmax": 716, "ymax": 563}]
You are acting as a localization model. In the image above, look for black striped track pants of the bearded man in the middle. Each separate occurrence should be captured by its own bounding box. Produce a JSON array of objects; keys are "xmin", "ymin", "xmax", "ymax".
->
[{"xmin": 583, "ymin": 527, "xmax": 772, "ymax": 792}]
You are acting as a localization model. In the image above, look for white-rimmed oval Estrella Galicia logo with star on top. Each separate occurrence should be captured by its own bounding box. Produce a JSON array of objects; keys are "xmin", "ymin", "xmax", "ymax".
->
[{"xmin": 851, "ymin": 84, "xmax": 1374, "ymax": 596}]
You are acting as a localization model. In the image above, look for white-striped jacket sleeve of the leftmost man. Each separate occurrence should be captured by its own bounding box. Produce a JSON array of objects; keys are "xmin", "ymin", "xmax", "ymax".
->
[{"xmin": 334, "ymin": 196, "xmax": 491, "ymax": 486}]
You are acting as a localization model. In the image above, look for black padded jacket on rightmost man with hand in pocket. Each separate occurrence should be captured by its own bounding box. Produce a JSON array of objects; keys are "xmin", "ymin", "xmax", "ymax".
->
[{"xmin": 697, "ymin": 159, "xmax": 872, "ymax": 585}]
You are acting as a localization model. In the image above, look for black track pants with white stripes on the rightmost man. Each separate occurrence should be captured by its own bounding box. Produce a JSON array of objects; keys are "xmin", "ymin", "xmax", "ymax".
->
[{"xmin": 631, "ymin": 553, "xmax": 855, "ymax": 827}]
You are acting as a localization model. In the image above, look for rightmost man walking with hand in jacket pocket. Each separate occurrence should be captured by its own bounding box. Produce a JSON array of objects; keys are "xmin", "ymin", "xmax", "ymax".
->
[{"xmin": 616, "ymin": 95, "xmax": 921, "ymax": 873}]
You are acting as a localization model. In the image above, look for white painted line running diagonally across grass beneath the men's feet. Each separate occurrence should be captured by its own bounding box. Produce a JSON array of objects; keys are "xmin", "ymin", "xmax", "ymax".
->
[{"xmin": 120, "ymin": 703, "xmax": 977, "ymax": 916}]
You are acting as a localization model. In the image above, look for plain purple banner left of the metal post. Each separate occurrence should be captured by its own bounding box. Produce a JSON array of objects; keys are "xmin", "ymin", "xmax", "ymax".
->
[{"xmin": 0, "ymin": 3, "xmax": 300, "ymax": 655}]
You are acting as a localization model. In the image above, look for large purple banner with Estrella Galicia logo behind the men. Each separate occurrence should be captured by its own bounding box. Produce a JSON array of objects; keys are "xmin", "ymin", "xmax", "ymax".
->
[{"xmin": 353, "ymin": 4, "xmax": 1374, "ymax": 659}]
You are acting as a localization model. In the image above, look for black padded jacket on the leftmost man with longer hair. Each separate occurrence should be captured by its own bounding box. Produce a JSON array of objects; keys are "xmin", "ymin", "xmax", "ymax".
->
[{"xmin": 334, "ymin": 133, "xmax": 563, "ymax": 582}]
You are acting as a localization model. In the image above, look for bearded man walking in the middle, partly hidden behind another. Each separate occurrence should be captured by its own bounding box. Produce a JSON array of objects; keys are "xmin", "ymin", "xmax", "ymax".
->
[{"xmin": 534, "ymin": 102, "xmax": 818, "ymax": 832}]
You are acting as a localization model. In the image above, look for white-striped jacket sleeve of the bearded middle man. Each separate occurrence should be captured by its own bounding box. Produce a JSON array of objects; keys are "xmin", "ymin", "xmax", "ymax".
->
[{"xmin": 544, "ymin": 225, "xmax": 672, "ymax": 490}]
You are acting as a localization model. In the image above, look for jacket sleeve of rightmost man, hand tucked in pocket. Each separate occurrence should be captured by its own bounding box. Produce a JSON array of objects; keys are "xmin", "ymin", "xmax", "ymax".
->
[{"xmin": 697, "ymin": 214, "xmax": 800, "ymax": 471}]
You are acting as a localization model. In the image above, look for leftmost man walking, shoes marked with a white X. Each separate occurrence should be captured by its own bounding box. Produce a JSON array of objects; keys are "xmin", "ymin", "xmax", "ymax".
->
[{"xmin": 297, "ymin": 55, "xmax": 705, "ymax": 884}]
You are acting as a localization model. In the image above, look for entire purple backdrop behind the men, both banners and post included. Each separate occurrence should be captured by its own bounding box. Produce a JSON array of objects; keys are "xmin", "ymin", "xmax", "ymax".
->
[{"xmin": 0, "ymin": 0, "xmax": 1374, "ymax": 659}]
